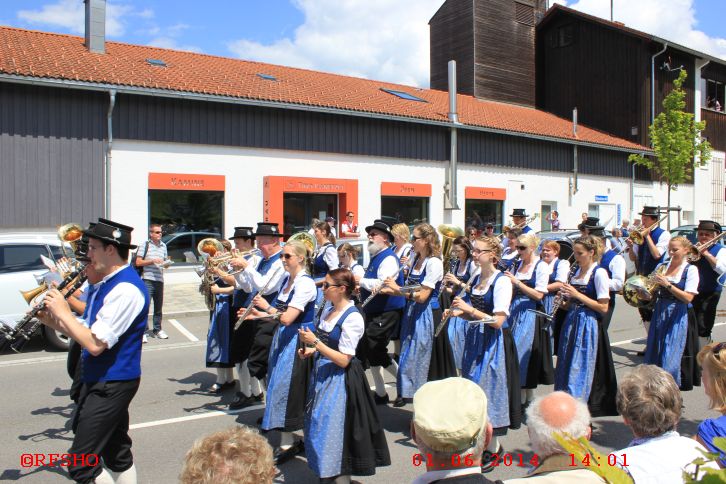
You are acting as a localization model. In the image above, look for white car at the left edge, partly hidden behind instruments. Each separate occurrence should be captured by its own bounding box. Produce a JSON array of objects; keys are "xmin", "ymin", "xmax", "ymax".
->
[{"xmin": 0, "ymin": 232, "xmax": 71, "ymax": 350}]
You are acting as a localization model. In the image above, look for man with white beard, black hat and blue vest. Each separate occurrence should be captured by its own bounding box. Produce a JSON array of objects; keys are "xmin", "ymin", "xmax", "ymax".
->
[{"xmin": 356, "ymin": 219, "xmax": 406, "ymax": 405}]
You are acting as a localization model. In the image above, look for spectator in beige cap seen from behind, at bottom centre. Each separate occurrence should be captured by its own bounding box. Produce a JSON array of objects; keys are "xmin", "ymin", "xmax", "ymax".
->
[{"xmin": 411, "ymin": 378, "xmax": 501, "ymax": 484}]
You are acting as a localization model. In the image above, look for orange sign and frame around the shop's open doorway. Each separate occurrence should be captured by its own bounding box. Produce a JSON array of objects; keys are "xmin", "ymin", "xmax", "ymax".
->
[{"xmin": 262, "ymin": 176, "xmax": 358, "ymax": 231}]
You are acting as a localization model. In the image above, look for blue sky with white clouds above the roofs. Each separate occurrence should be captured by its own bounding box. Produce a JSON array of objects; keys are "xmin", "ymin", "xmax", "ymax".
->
[{"xmin": 0, "ymin": 0, "xmax": 726, "ymax": 87}]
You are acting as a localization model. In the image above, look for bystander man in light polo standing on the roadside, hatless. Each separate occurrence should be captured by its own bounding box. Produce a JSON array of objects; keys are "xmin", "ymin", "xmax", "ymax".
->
[{"xmin": 135, "ymin": 224, "xmax": 169, "ymax": 343}]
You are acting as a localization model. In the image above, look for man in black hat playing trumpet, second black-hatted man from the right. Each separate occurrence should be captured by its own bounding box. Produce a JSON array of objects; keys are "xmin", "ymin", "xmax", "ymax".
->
[{"xmin": 625, "ymin": 205, "xmax": 671, "ymax": 346}]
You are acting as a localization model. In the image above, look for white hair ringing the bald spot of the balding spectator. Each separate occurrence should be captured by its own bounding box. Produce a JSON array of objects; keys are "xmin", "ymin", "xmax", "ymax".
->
[{"xmin": 527, "ymin": 392, "xmax": 590, "ymax": 458}]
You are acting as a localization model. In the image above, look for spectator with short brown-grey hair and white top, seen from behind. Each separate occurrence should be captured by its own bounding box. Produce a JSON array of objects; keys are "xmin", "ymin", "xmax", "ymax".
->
[{"xmin": 617, "ymin": 365, "xmax": 717, "ymax": 484}]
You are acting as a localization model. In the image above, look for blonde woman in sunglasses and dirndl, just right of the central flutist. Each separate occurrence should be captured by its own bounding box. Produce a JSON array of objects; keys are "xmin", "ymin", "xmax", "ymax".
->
[{"xmin": 504, "ymin": 234, "xmax": 552, "ymax": 406}]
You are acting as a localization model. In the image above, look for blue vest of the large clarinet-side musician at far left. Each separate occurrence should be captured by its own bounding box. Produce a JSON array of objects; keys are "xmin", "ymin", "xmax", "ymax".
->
[{"xmin": 81, "ymin": 266, "xmax": 149, "ymax": 383}]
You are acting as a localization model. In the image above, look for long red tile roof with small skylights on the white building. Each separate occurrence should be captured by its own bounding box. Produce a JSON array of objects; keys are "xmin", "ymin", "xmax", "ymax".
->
[{"xmin": 0, "ymin": 27, "xmax": 648, "ymax": 151}]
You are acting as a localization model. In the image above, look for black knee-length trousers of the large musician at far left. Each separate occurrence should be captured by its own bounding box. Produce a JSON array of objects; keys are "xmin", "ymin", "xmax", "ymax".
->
[{"xmin": 68, "ymin": 378, "xmax": 140, "ymax": 483}]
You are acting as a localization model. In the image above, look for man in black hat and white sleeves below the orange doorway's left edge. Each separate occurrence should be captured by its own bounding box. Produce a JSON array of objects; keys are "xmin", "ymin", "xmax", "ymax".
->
[{"xmin": 230, "ymin": 222, "xmax": 285, "ymax": 396}]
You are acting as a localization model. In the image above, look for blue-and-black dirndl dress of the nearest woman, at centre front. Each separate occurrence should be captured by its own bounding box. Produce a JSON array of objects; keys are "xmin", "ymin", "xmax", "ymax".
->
[{"xmin": 305, "ymin": 306, "xmax": 391, "ymax": 478}]
